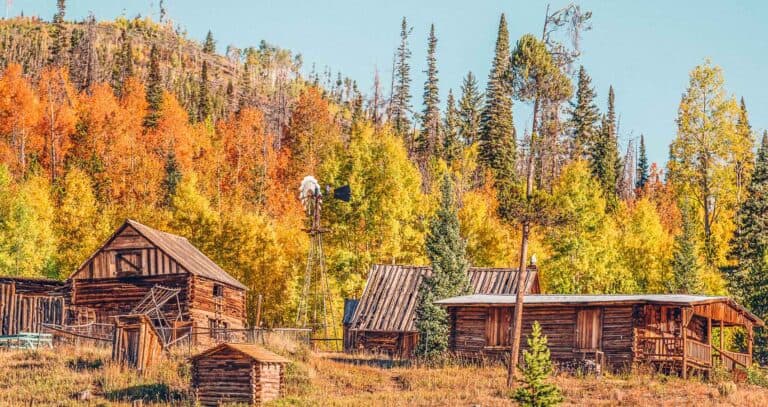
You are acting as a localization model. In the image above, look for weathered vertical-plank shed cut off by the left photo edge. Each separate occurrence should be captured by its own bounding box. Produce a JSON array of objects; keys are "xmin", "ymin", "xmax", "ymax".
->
[{"xmin": 0, "ymin": 277, "xmax": 64, "ymax": 336}]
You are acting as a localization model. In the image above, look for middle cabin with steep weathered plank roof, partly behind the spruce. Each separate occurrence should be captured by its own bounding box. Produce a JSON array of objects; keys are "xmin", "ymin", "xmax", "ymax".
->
[{"xmin": 344, "ymin": 264, "xmax": 539, "ymax": 357}]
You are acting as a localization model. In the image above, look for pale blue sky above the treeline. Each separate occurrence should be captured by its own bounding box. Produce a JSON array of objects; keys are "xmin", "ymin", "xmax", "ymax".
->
[{"xmin": 9, "ymin": 0, "xmax": 768, "ymax": 163}]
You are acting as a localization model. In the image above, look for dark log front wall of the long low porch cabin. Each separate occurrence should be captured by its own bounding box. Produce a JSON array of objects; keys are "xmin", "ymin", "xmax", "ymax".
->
[{"xmin": 449, "ymin": 306, "xmax": 633, "ymax": 369}]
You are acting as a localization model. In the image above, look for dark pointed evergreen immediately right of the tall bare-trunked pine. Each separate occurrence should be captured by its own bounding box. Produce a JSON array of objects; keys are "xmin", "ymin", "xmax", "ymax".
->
[{"xmin": 571, "ymin": 66, "xmax": 600, "ymax": 159}]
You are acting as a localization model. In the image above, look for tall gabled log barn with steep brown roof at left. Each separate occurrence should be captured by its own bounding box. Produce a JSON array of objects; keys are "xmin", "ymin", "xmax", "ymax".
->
[{"xmin": 67, "ymin": 220, "xmax": 246, "ymax": 343}]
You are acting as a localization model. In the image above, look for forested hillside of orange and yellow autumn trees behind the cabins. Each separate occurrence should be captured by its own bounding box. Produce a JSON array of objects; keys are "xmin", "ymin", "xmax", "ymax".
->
[{"xmin": 0, "ymin": 1, "xmax": 768, "ymax": 360}]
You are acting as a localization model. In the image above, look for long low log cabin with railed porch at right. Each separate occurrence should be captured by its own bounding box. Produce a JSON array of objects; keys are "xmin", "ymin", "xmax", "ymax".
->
[{"xmin": 437, "ymin": 295, "xmax": 764, "ymax": 377}]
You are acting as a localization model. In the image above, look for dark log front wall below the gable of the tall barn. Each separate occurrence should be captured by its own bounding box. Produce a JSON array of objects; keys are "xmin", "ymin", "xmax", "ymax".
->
[{"xmin": 69, "ymin": 274, "xmax": 190, "ymax": 323}]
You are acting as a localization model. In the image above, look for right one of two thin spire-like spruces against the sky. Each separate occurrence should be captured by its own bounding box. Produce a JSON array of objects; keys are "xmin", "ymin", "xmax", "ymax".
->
[{"xmin": 416, "ymin": 24, "xmax": 440, "ymax": 162}]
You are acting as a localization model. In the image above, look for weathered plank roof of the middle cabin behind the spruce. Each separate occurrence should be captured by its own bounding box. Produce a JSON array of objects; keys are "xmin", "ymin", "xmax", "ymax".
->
[{"xmin": 349, "ymin": 264, "xmax": 539, "ymax": 332}]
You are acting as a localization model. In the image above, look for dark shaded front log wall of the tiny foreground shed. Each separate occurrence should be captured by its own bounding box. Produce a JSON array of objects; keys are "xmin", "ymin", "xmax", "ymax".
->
[{"xmin": 192, "ymin": 349, "xmax": 258, "ymax": 406}]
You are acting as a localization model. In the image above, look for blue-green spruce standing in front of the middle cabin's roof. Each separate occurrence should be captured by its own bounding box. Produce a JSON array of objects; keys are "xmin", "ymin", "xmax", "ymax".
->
[{"xmin": 416, "ymin": 175, "xmax": 469, "ymax": 358}]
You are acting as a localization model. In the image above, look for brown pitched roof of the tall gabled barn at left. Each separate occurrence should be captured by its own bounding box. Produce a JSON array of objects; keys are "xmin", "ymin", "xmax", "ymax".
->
[{"xmin": 70, "ymin": 219, "xmax": 248, "ymax": 290}]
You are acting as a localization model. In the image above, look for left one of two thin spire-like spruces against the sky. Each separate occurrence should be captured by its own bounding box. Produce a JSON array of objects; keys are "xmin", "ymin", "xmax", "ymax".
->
[{"xmin": 390, "ymin": 17, "xmax": 411, "ymax": 137}]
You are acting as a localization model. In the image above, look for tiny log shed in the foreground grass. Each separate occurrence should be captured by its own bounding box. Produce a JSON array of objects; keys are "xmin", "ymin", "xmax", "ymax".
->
[{"xmin": 192, "ymin": 343, "xmax": 289, "ymax": 406}]
